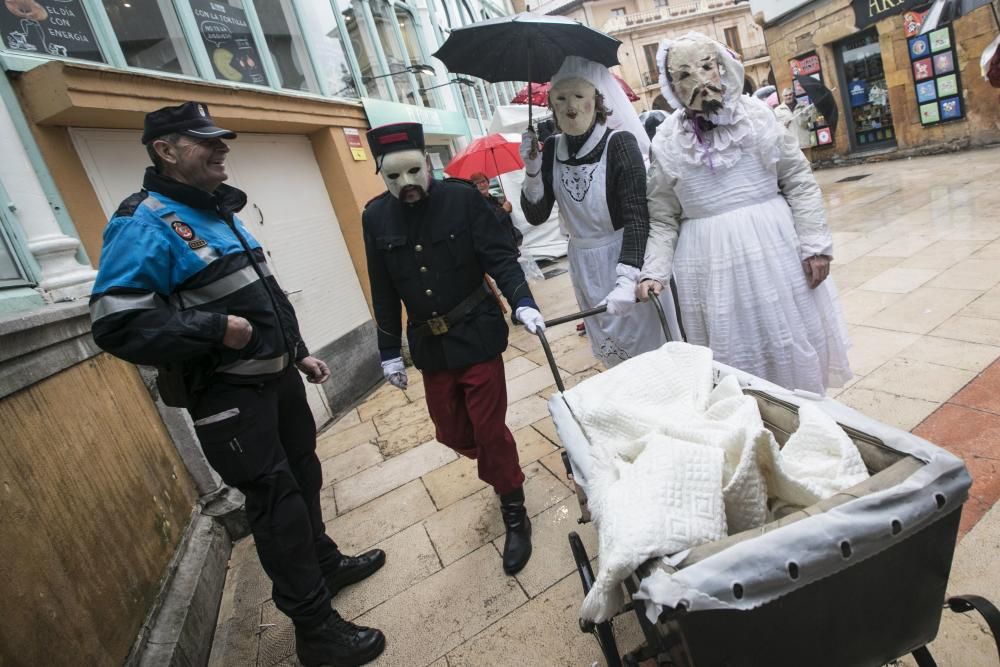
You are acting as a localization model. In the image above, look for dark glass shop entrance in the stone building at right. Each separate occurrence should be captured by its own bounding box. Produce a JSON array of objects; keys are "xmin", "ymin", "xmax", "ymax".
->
[{"xmin": 837, "ymin": 30, "xmax": 896, "ymax": 150}]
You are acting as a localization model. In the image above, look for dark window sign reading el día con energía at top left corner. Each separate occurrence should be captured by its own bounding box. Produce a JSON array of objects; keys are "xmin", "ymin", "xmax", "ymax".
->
[{"xmin": 0, "ymin": 0, "xmax": 104, "ymax": 62}]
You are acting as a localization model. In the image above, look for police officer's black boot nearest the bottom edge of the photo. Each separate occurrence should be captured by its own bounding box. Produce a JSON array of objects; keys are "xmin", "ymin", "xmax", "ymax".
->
[{"xmin": 295, "ymin": 612, "xmax": 385, "ymax": 667}]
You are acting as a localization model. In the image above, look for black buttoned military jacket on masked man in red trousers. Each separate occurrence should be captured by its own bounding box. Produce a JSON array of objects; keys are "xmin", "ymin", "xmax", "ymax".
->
[{"xmin": 362, "ymin": 179, "xmax": 535, "ymax": 371}]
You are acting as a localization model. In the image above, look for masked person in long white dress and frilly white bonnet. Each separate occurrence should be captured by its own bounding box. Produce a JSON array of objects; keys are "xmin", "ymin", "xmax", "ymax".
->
[{"xmin": 637, "ymin": 33, "xmax": 851, "ymax": 394}]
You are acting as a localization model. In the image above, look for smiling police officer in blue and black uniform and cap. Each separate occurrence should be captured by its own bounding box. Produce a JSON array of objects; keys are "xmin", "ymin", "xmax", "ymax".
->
[{"xmin": 90, "ymin": 102, "xmax": 385, "ymax": 665}]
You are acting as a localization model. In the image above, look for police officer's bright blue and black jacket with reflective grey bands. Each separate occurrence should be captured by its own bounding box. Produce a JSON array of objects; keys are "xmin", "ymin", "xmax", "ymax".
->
[{"xmin": 90, "ymin": 169, "xmax": 309, "ymax": 392}]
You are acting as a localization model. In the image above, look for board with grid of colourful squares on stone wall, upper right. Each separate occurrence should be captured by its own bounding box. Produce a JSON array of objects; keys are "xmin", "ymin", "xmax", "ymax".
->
[{"xmin": 904, "ymin": 24, "xmax": 965, "ymax": 127}]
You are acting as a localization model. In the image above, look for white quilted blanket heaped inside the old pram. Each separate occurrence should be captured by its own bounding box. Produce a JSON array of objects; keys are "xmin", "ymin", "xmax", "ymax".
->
[{"xmin": 564, "ymin": 343, "xmax": 868, "ymax": 622}]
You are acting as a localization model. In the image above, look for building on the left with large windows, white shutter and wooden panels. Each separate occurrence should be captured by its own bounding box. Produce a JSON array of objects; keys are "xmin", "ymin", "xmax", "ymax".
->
[{"xmin": 0, "ymin": 0, "xmax": 516, "ymax": 665}]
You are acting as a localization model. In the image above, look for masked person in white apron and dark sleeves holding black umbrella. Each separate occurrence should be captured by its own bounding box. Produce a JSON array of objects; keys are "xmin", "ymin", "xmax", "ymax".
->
[{"xmin": 521, "ymin": 56, "xmax": 679, "ymax": 367}]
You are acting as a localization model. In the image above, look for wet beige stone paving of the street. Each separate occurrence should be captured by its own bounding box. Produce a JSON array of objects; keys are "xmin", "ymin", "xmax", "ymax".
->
[{"xmin": 211, "ymin": 149, "xmax": 1000, "ymax": 667}]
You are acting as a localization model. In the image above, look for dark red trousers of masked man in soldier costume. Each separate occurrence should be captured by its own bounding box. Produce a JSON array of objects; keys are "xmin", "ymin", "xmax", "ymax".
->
[{"xmin": 424, "ymin": 357, "xmax": 524, "ymax": 495}]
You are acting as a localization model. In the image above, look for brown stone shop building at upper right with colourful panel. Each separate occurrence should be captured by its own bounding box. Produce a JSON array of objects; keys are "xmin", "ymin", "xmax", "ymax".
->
[{"xmin": 751, "ymin": 0, "xmax": 1000, "ymax": 162}]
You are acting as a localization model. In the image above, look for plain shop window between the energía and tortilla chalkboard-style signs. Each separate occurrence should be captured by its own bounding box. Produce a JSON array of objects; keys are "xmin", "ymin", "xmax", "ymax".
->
[{"xmin": 104, "ymin": 0, "xmax": 198, "ymax": 76}]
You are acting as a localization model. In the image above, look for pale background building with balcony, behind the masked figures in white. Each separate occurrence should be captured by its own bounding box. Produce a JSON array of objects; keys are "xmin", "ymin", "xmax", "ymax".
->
[{"xmin": 532, "ymin": 0, "xmax": 772, "ymax": 112}]
